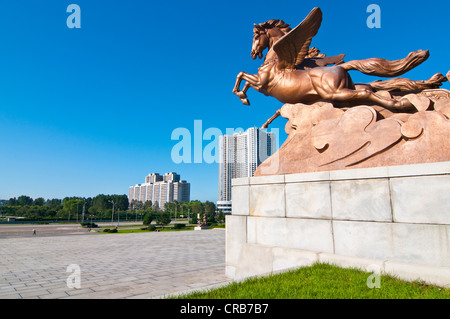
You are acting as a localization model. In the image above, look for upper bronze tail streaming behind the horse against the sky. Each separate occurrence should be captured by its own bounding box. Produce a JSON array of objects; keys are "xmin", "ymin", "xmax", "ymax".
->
[{"xmin": 339, "ymin": 50, "xmax": 430, "ymax": 77}]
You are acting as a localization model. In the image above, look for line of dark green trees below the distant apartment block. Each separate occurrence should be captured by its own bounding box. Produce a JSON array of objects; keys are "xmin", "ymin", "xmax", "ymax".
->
[{"xmin": 0, "ymin": 194, "xmax": 225, "ymax": 224}]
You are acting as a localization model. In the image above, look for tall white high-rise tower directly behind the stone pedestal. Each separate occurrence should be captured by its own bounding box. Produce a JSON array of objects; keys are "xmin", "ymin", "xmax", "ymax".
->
[{"xmin": 217, "ymin": 127, "xmax": 276, "ymax": 213}]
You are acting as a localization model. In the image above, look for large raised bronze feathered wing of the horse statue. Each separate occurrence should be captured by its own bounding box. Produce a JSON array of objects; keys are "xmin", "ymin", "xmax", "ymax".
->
[{"xmin": 273, "ymin": 8, "xmax": 322, "ymax": 69}]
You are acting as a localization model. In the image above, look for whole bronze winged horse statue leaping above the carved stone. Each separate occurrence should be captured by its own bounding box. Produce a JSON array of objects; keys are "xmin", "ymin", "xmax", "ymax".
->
[{"xmin": 233, "ymin": 8, "xmax": 447, "ymax": 116}]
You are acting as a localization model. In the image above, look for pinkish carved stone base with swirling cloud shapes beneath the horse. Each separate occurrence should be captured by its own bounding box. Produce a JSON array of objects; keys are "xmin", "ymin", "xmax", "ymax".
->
[{"xmin": 255, "ymin": 94, "xmax": 450, "ymax": 176}]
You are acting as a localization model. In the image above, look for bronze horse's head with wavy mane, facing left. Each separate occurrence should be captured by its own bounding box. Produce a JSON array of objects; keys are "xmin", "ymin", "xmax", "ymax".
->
[{"xmin": 251, "ymin": 19, "xmax": 291, "ymax": 60}]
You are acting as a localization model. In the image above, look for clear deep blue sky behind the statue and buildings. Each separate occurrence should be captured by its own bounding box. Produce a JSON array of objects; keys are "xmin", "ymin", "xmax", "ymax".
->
[{"xmin": 0, "ymin": 0, "xmax": 450, "ymax": 201}]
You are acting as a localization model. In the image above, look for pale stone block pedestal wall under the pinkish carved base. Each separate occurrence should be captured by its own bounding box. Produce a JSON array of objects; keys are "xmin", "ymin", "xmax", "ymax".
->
[{"xmin": 226, "ymin": 162, "xmax": 450, "ymax": 286}]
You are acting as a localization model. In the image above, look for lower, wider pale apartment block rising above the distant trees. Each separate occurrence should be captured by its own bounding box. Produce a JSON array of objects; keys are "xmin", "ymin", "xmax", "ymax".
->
[{"xmin": 128, "ymin": 172, "xmax": 191, "ymax": 209}]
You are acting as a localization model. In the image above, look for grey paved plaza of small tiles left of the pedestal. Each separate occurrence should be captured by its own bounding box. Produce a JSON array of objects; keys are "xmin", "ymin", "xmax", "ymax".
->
[{"xmin": 0, "ymin": 229, "xmax": 229, "ymax": 299}]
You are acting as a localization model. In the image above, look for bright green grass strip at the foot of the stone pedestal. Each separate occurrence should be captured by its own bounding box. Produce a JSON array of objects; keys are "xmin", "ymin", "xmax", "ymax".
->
[{"xmin": 176, "ymin": 263, "xmax": 450, "ymax": 299}]
